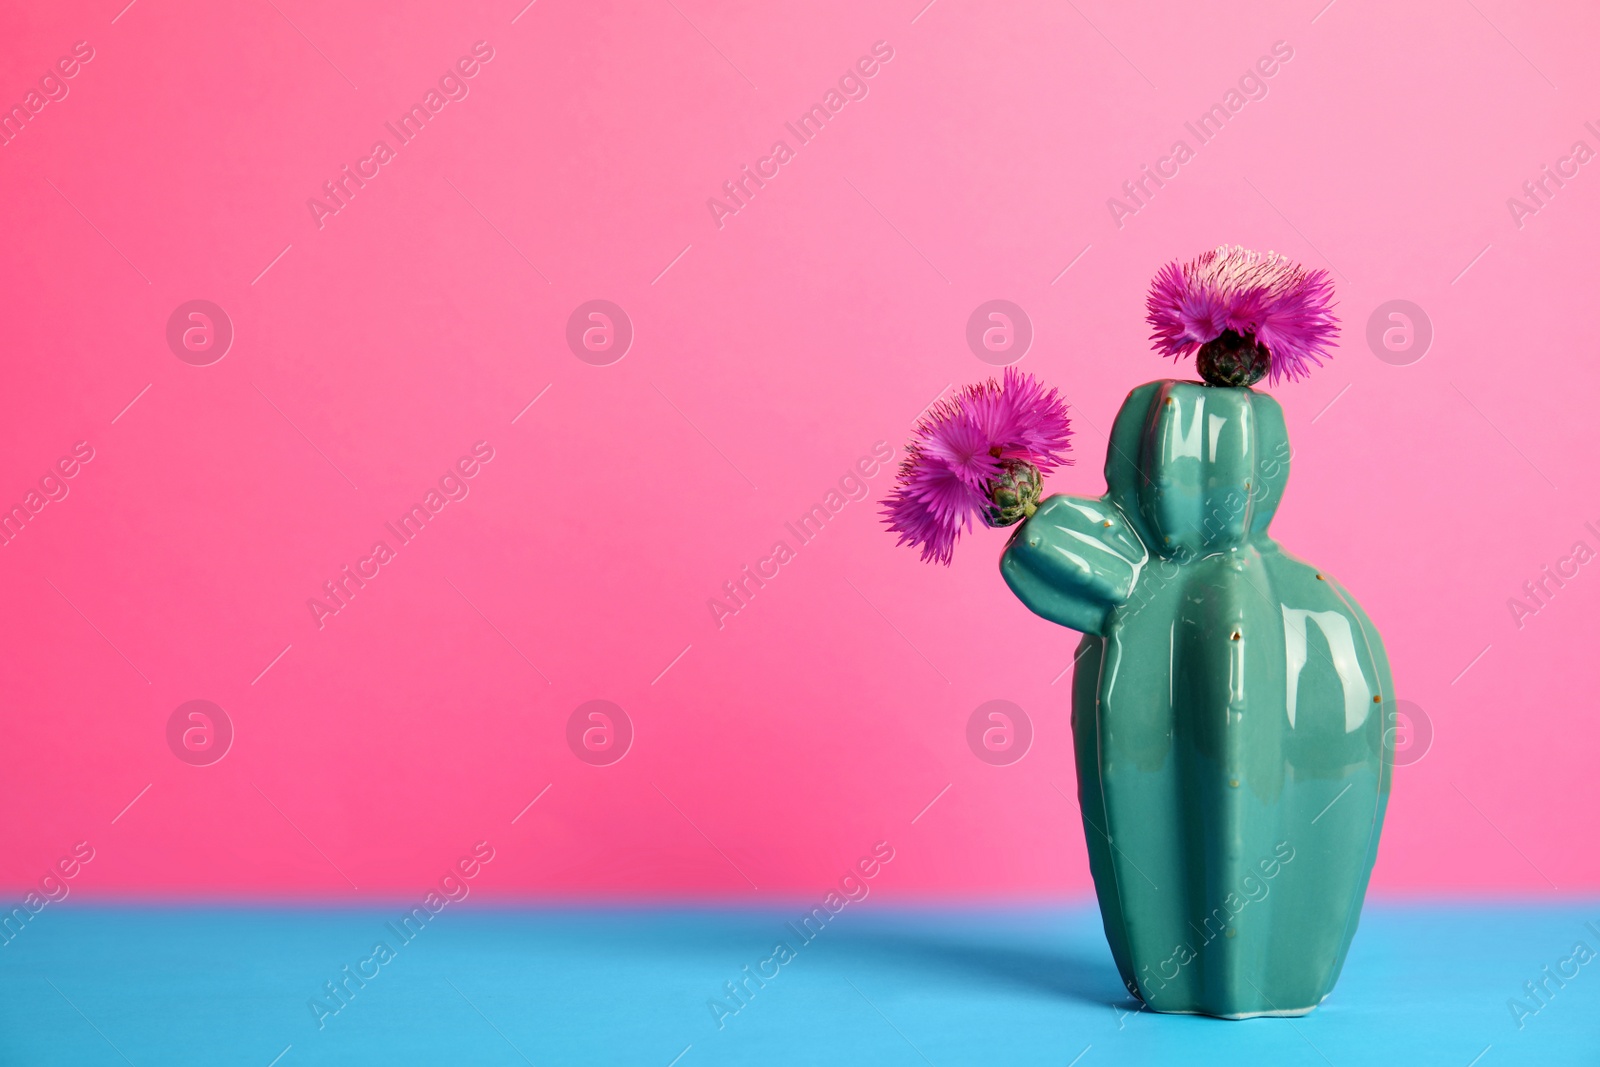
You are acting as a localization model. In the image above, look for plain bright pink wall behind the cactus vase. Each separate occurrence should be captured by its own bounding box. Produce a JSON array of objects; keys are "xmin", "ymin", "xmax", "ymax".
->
[{"xmin": 0, "ymin": 0, "xmax": 1600, "ymax": 901}]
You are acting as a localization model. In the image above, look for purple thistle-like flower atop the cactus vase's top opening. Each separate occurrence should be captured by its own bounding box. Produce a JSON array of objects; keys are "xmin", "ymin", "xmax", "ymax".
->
[{"xmin": 1146, "ymin": 245, "xmax": 1339, "ymax": 384}]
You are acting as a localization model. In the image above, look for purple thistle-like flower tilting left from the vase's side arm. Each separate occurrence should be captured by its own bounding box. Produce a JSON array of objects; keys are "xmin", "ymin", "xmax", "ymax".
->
[{"xmin": 883, "ymin": 366, "xmax": 1072, "ymax": 565}]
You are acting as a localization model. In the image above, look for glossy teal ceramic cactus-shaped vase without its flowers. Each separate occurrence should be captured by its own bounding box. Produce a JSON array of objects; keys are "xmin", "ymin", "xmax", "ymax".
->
[{"xmin": 1000, "ymin": 381, "xmax": 1394, "ymax": 1019}]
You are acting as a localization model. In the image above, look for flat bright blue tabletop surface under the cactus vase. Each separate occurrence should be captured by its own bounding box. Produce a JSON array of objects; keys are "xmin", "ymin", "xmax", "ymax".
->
[{"xmin": 0, "ymin": 899, "xmax": 1600, "ymax": 1067}]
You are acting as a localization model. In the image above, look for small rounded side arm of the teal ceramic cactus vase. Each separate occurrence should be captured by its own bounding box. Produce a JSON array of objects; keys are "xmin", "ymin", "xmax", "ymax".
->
[{"xmin": 1000, "ymin": 496, "xmax": 1149, "ymax": 635}]
